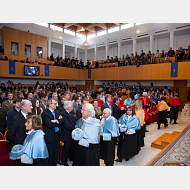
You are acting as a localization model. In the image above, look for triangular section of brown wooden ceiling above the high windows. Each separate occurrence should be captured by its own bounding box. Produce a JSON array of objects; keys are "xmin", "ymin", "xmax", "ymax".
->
[{"xmin": 49, "ymin": 23, "xmax": 125, "ymax": 36}]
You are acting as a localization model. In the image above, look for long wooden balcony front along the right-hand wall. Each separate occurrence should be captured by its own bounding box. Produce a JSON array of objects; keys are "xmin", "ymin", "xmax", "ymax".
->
[{"xmin": 87, "ymin": 62, "xmax": 190, "ymax": 80}]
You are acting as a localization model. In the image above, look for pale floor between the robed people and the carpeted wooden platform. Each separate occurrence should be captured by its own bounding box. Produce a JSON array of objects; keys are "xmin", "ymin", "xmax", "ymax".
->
[{"xmin": 64, "ymin": 113, "xmax": 190, "ymax": 166}]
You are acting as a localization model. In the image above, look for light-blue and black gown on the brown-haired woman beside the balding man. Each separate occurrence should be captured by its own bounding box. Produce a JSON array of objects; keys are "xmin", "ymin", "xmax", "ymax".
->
[{"xmin": 117, "ymin": 114, "xmax": 141, "ymax": 159}]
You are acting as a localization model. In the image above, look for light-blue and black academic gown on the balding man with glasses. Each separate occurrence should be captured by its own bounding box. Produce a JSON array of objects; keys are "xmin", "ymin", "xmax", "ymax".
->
[{"xmin": 100, "ymin": 116, "xmax": 120, "ymax": 166}]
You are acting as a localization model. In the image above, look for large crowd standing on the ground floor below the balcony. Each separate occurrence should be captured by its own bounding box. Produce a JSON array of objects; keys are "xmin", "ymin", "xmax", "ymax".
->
[{"xmin": 0, "ymin": 80, "xmax": 181, "ymax": 166}]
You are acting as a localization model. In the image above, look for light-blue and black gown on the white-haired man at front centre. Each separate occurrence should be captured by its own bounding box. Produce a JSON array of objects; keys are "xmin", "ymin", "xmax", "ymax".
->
[{"xmin": 73, "ymin": 117, "xmax": 100, "ymax": 166}]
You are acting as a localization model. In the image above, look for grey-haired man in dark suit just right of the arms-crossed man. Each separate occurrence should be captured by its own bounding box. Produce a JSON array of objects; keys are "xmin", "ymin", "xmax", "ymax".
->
[{"xmin": 59, "ymin": 101, "xmax": 76, "ymax": 166}]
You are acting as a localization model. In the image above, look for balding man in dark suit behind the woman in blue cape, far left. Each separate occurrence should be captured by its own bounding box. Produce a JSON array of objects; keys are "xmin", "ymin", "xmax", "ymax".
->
[{"xmin": 7, "ymin": 100, "xmax": 33, "ymax": 165}]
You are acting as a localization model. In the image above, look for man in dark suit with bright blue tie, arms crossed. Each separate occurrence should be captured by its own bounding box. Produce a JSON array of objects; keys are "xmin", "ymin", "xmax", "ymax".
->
[{"xmin": 42, "ymin": 98, "xmax": 60, "ymax": 166}]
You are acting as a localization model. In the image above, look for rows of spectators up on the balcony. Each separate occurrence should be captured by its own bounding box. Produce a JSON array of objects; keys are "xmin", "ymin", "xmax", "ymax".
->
[{"xmin": 0, "ymin": 46, "xmax": 190, "ymax": 69}]
